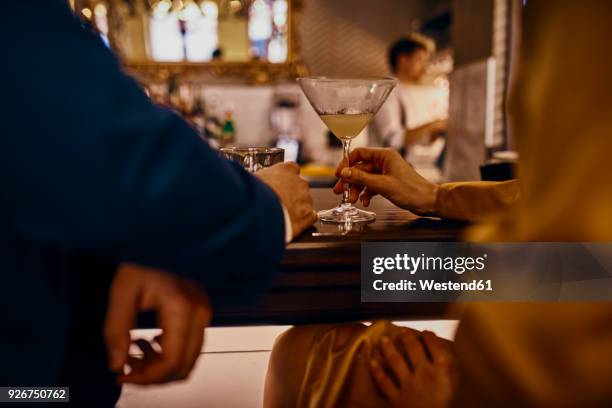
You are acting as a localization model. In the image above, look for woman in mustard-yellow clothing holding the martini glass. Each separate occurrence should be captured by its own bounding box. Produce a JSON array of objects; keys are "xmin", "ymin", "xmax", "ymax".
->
[{"xmin": 265, "ymin": 0, "xmax": 612, "ymax": 407}]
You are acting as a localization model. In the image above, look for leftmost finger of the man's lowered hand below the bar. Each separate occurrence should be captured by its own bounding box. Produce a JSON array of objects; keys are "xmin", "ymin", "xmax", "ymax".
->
[{"xmin": 104, "ymin": 265, "xmax": 139, "ymax": 372}]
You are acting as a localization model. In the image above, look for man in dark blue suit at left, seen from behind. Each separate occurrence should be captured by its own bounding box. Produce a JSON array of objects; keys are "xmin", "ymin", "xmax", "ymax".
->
[{"xmin": 0, "ymin": 0, "xmax": 315, "ymax": 406}]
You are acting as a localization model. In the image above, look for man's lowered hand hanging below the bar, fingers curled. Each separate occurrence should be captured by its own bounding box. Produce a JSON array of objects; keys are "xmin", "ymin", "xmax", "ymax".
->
[{"xmin": 104, "ymin": 264, "xmax": 212, "ymax": 384}]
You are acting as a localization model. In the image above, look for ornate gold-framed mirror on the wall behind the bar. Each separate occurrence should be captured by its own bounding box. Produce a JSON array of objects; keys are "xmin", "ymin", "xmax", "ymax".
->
[{"xmin": 70, "ymin": 0, "xmax": 307, "ymax": 83}]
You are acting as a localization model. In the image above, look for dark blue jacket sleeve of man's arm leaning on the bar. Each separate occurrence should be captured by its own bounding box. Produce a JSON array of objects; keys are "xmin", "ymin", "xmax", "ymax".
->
[{"xmin": 0, "ymin": 0, "xmax": 284, "ymax": 290}]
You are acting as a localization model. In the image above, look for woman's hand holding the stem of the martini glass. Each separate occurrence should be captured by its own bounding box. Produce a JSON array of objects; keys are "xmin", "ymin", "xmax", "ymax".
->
[{"xmin": 334, "ymin": 148, "xmax": 438, "ymax": 215}]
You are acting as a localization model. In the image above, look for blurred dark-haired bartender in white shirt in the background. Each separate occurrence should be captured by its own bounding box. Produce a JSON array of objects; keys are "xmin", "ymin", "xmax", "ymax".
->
[{"xmin": 369, "ymin": 33, "xmax": 448, "ymax": 181}]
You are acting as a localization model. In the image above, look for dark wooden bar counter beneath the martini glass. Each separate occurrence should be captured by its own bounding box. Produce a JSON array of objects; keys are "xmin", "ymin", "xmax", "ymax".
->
[{"xmin": 213, "ymin": 189, "xmax": 465, "ymax": 325}]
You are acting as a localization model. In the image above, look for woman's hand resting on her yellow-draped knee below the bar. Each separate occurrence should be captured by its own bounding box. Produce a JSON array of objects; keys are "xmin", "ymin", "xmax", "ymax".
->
[{"xmin": 370, "ymin": 329, "xmax": 457, "ymax": 408}]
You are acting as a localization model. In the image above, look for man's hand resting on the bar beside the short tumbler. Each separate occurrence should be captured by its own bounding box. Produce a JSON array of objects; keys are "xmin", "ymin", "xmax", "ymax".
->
[{"xmin": 255, "ymin": 162, "xmax": 317, "ymax": 238}]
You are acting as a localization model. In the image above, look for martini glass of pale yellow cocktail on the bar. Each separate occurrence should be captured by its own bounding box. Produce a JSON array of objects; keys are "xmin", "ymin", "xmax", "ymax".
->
[{"xmin": 298, "ymin": 77, "xmax": 396, "ymax": 223}]
